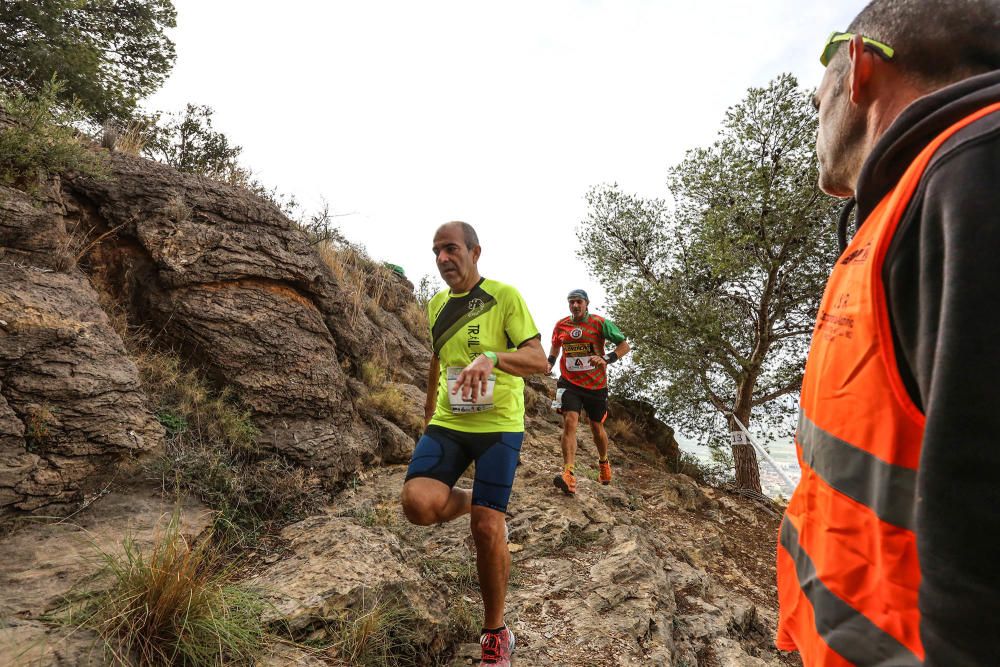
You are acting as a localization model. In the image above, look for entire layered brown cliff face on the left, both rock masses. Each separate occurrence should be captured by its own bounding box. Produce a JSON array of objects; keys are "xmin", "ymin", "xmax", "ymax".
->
[{"xmin": 0, "ymin": 140, "xmax": 429, "ymax": 511}]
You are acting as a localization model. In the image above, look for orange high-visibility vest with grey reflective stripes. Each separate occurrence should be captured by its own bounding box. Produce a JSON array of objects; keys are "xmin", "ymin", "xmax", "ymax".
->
[{"xmin": 775, "ymin": 103, "xmax": 1000, "ymax": 667}]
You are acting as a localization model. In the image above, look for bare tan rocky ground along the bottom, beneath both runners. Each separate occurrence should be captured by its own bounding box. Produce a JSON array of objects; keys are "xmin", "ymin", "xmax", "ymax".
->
[{"xmin": 0, "ymin": 384, "xmax": 800, "ymax": 667}]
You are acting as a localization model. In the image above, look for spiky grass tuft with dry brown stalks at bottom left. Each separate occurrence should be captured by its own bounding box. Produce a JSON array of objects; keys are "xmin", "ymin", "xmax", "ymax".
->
[{"xmin": 57, "ymin": 513, "xmax": 266, "ymax": 666}]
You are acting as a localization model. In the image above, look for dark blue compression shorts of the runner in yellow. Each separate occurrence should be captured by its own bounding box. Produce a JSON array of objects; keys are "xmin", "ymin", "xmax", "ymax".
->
[{"xmin": 406, "ymin": 424, "xmax": 524, "ymax": 512}]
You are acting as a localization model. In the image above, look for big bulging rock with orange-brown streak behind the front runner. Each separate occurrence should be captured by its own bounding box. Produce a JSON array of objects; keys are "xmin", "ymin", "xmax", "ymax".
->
[{"xmin": 64, "ymin": 154, "xmax": 430, "ymax": 482}]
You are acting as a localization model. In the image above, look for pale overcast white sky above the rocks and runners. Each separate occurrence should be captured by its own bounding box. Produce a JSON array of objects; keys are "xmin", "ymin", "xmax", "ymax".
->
[{"xmin": 147, "ymin": 0, "xmax": 865, "ymax": 340}]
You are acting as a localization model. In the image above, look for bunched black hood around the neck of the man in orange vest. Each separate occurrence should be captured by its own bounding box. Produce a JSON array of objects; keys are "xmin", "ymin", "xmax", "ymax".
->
[{"xmin": 855, "ymin": 70, "xmax": 1000, "ymax": 225}]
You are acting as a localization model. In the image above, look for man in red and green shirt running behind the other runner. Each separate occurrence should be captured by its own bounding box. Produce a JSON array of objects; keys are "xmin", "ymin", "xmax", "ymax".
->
[{"xmin": 548, "ymin": 289, "xmax": 631, "ymax": 495}]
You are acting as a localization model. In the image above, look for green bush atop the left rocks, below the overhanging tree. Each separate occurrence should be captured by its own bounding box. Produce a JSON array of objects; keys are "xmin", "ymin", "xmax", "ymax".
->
[{"xmin": 0, "ymin": 79, "xmax": 107, "ymax": 189}]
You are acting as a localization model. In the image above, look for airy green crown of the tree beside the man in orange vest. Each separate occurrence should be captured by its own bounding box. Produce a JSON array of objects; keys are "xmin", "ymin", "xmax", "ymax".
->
[{"xmin": 578, "ymin": 75, "xmax": 837, "ymax": 470}]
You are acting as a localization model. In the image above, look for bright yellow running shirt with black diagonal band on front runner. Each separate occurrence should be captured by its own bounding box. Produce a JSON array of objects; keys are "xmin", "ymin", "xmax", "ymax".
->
[{"xmin": 427, "ymin": 278, "xmax": 539, "ymax": 433}]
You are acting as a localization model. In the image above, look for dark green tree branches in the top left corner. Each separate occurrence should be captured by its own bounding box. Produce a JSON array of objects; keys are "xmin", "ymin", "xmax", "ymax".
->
[{"xmin": 0, "ymin": 0, "xmax": 176, "ymax": 123}]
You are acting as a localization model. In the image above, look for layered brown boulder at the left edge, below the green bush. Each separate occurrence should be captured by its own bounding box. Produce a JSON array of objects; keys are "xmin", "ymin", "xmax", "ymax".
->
[{"xmin": 0, "ymin": 188, "xmax": 163, "ymax": 516}]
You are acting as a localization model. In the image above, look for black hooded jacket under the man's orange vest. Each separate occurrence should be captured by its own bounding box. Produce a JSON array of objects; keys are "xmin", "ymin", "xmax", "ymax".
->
[{"xmin": 857, "ymin": 71, "xmax": 1000, "ymax": 667}]
